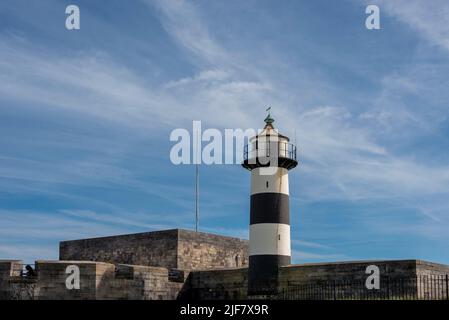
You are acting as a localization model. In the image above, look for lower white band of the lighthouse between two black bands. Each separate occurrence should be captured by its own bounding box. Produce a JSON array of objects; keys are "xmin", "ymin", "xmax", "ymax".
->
[{"xmin": 249, "ymin": 223, "xmax": 291, "ymax": 256}]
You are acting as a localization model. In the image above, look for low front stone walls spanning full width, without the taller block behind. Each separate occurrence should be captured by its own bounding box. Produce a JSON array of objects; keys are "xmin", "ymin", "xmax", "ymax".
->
[{"xmin": 0, "ymin": 260, "xmax": 449, "ymax": 300}]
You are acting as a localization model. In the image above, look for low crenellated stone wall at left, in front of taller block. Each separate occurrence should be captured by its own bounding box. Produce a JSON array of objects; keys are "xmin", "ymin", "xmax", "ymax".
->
[{"xmin": 0, "ymin": 261, "xmax": 185, "ymax": 300}]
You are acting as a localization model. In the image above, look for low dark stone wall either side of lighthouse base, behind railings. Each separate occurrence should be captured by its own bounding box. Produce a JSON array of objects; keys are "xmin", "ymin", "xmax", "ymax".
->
[{"xmin": 180, "ymin": 260, "xmax": 449, "ymax": 300}]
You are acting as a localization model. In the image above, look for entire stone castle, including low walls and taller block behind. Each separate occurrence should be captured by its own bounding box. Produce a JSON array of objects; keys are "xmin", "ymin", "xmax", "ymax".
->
[{"xmin": 5, "ymin": 229, "xmax": 449, "ymax": 300}]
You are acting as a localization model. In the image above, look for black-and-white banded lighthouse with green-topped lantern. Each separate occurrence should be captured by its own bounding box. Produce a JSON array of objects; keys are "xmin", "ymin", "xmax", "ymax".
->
[{"xmin": 242, "ymin": 114, "xmax": 298, "ymax": 295}]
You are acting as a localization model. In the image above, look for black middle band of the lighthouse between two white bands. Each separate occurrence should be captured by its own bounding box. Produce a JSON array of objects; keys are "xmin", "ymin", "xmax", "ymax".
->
[{"xmin": 249, "ymin": 193, "xmax": 290, "ymax": 225}]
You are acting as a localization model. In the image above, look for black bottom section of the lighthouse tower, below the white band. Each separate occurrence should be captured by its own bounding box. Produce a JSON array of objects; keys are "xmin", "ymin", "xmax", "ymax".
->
[{"xmin": 248, "ymin": 255, "xmax": 291, "ymax": 296}]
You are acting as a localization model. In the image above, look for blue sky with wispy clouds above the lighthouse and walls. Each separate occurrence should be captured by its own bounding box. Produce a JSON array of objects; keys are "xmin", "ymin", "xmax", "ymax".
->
[{"xmin": 0, "ymin": 0, "xmax": 449, "ymax": 263}]
